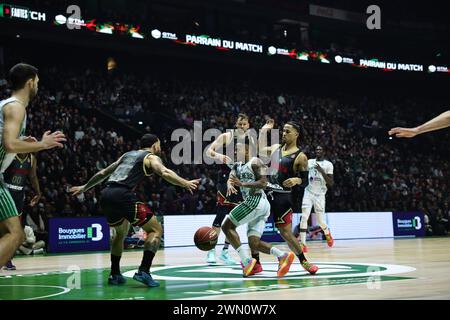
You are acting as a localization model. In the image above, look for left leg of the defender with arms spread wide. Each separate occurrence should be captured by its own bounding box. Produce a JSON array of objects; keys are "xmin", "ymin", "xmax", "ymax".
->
[{"xmin": 108, "ymin": 219, "xmax": 130, "ymax": 285}]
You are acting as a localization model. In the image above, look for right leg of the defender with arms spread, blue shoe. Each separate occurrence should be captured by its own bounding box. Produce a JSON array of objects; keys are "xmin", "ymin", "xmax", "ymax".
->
[{"xmin": 133, "ymin": 203, "xmax": 163, "ymax": 287}]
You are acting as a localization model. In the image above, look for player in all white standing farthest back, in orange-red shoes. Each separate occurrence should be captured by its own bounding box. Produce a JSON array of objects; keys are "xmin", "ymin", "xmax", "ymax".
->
[{"xmin": 300, "ymin": 146, "xmax": 334, "ymax": 252}]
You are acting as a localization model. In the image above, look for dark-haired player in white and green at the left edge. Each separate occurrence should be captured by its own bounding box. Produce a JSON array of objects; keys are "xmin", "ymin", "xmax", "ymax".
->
[{"xmin": 0, "ymin": 63, "xmax": 66, "ymax": 266}]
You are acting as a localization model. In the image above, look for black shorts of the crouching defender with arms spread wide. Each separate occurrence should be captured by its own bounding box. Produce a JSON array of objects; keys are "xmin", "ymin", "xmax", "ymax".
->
[{"xmin": 100, "ymin": 186, "xmax": 153, "ymax": 227}]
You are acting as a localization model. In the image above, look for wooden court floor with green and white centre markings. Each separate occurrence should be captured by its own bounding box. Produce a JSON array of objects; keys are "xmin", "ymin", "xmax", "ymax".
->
[{"xmin": 0, "ymin": 237, "xmax": 450, "ymax": 300}]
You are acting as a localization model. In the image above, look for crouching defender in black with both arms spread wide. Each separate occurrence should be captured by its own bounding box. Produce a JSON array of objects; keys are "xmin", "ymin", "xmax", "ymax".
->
[{"xmin": 70, "ymin": 134, "xmax": 199, "ymax": 287}]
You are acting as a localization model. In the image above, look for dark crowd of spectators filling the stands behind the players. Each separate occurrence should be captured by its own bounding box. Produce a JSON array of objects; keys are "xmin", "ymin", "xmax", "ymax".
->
[{"xmin": 1, "ymin": 68, "xmax": 450, "ymax": 234}]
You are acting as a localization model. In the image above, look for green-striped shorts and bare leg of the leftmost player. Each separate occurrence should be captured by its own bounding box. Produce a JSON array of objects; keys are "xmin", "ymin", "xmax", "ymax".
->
[{"xmin": 0, "ymin": 185, "xmax": 25, "ymax": 267}]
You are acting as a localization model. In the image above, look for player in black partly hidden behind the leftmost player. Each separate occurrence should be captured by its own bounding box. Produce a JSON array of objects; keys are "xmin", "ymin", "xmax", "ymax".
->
[{"xmin": 3, "ymin": 153, "xmax": 41, "ymax": 270}]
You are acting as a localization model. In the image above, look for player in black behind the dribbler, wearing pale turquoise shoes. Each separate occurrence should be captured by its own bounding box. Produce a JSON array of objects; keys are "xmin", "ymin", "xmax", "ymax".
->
[{"xmin": 206, "ymin": 113, "xmax": 250, "ymax": 264}]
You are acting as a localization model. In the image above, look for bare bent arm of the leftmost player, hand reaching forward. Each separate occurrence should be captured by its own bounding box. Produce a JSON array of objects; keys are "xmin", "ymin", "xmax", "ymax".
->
[{"xmin": 2, "ymin": 102, "xmax": 66, "ymax": 153}]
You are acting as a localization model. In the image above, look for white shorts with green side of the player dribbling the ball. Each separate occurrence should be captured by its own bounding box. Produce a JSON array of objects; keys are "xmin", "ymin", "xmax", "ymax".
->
[{"xmin": 228, "ymin": 193, "xmax": 270, "ymax": 238}]
